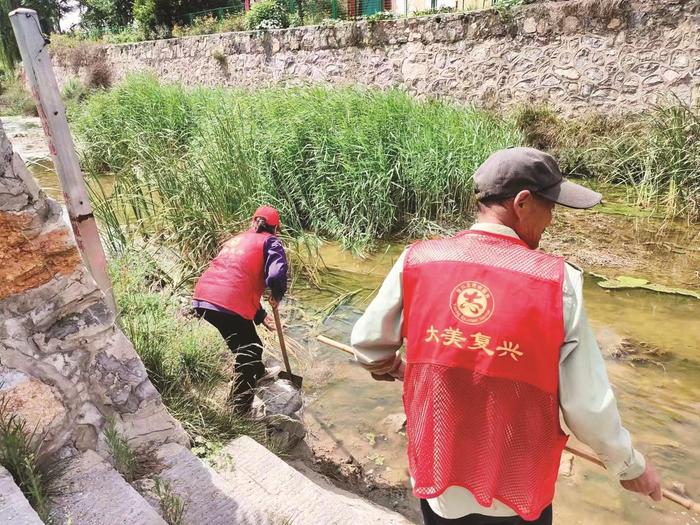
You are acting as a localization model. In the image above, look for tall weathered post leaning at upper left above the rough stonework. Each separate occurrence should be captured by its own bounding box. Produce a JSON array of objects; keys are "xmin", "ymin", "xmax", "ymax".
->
[{"xmin": 10, "ymin": 9, "xmax": 116, "ymax": 312}]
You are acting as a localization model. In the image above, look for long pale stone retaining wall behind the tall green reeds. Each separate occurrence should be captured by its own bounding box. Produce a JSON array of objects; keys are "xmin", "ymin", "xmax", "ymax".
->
[{"xmin": 56, "ymin": 0, "xmax": 700, "ymax": 113}]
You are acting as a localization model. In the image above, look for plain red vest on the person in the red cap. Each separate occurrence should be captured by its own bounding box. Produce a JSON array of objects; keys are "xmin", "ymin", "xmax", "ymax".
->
[{"xmin": 193, "ymin": 231, "xmax": 270, "ymax": 319}]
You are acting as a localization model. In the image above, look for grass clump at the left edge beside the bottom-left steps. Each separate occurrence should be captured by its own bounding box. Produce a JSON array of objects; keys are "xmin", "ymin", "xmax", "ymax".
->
[{"xmin": 0, "ymin": 397, "xmax": 51, "ymax": 523}]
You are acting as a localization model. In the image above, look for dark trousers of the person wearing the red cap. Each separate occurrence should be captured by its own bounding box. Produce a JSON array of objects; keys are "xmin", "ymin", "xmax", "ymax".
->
[{"xmin": 195, "ymin": 308, "xmax": 265, "ymax": 413}]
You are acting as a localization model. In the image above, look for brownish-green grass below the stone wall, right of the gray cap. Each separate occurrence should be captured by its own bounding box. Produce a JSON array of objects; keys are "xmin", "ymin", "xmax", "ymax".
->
[{"xmin": 514, "ymin": 100, "xmax": 700, "ymax": 222}]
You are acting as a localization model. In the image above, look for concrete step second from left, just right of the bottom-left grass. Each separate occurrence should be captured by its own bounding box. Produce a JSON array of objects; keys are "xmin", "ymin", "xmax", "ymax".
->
[{"xmin": 51, "ymin": 450, "xmax": 166, "ymax": 525}]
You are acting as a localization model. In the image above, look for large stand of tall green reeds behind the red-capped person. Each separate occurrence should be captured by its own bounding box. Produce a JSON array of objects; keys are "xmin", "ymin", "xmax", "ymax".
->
[{"xmin": 77, "ymin": 76, "xmax": 521, "ymax": 262}]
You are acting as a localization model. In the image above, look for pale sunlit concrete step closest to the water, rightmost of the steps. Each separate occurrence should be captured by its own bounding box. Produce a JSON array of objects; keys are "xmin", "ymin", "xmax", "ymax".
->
[{"xmin": 215, "ymin": 437, "xmax": 411, "ymax": 525}]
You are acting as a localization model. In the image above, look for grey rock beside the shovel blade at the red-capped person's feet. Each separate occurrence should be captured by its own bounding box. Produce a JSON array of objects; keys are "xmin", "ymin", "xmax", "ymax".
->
[{"xmin": 251, "ymin": 379, "xmax": 306, "ymax": 451}]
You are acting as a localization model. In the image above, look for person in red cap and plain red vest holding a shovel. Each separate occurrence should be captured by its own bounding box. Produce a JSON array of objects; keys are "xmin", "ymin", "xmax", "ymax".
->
[{"xmin": 192, "ymin": 206, "xmax": 287, "ymax": 414}]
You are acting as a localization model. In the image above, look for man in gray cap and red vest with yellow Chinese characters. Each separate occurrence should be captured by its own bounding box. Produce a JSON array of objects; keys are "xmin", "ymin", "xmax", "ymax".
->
[{"xmin": 351, "ymin": 148, "xmax": 661, "ymax": 525}]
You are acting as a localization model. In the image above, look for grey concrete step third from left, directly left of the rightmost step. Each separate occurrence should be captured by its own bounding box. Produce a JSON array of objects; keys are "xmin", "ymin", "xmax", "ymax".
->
[{"xmin": 152, "ymin": 443, "xmax": 270, "ymax": 525}]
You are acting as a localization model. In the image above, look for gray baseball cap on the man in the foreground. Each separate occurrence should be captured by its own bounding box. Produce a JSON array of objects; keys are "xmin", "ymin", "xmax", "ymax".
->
[{"xmin": 474, "ymin": 148, "xmax": 603, "ymax": 209}]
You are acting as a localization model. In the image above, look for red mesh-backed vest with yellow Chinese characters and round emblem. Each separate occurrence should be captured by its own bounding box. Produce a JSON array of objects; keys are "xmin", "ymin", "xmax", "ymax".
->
[{"xmin": 403, "ymin": 231, "xmax": 566, "ymax": 520}]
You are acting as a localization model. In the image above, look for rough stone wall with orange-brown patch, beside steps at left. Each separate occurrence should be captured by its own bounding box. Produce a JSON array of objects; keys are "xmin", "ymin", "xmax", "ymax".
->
[{"xmin": 0, "ymin": 122, "xmax": 189, "ymax": 456}]
